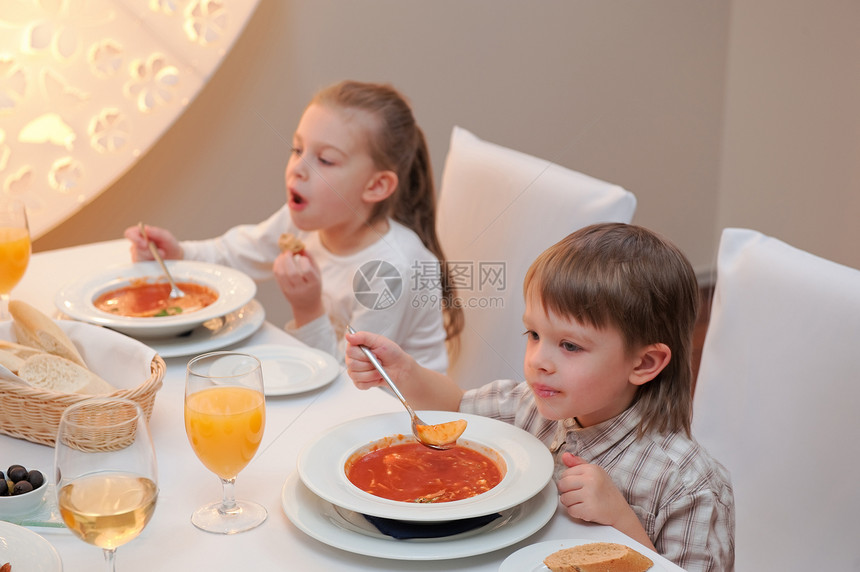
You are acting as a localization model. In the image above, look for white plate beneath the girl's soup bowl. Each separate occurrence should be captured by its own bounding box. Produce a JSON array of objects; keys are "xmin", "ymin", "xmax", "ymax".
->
[{"xmin": 144, "ymin": 300, "xmax": 266, "ymax": 358}]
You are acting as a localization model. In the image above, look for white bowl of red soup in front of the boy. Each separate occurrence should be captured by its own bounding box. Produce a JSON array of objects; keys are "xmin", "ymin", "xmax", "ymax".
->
[{"xmin": 297, "ymin": 411, "xmax": 553, "ymax": 522}]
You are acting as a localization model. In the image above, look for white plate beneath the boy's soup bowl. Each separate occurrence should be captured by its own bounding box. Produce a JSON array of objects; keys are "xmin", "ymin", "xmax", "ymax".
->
[{"xmin": 281, "ymin": 472, "xmax": 558, "ymax": 560}]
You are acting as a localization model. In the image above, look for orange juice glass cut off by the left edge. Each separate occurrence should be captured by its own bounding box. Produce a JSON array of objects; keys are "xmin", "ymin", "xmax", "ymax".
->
[{"xmin": 0, "ymin": 198, "xmax": 30, "ymax": 320}]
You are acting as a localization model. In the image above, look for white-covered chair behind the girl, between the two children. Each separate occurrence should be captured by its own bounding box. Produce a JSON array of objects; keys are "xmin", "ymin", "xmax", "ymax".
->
[{"xmin": 437, "ymin": 127, "xmax": 636, "ymax": 388}]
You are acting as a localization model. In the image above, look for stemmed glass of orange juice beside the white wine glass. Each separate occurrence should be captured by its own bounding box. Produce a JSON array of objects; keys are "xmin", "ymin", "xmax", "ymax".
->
[{"xmin": 185, "ymin": 352, "xmax": 268, "ymax": 534}]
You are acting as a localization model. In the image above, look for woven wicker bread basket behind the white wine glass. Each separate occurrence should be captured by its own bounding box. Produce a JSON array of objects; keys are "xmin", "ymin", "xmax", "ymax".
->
[{"xmin": 0, "ymin": 354, "xmax": 166, "ymax": 447}]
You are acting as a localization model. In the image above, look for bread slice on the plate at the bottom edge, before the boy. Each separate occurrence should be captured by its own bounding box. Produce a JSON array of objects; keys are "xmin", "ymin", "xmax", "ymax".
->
[{"xmin": 543, "ymin": 542, "xmax": 654, "ymax": 572}]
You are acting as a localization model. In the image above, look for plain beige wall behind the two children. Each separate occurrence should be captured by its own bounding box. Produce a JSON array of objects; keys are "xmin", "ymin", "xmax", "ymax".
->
[{"xmin": 34, "ymin": 0, "xmax": 860, "ymax": 321}]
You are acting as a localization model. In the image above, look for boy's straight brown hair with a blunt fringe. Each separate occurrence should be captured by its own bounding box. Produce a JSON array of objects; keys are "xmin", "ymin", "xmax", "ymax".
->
[{"xmin": 523, "ymin": 223, "xmax": 699, "ymax": 436}]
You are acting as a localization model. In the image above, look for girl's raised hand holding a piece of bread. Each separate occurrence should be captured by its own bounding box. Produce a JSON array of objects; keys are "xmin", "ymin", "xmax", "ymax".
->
[{"xmin": 272, "ymin": 252, "xmax": 325, "ymax": 326}]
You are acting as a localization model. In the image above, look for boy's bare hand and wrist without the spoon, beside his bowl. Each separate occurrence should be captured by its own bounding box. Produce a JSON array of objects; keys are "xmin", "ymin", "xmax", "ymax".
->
[{"xmin": 557, "ymin": 453, "xmax": 654, "ymax": 549}]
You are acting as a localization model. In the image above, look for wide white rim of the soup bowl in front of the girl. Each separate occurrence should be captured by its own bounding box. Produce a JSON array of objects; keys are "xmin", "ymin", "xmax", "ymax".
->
[{"xmin": 54, "ymin": 260, "xmax": 257, "ymax": 338}]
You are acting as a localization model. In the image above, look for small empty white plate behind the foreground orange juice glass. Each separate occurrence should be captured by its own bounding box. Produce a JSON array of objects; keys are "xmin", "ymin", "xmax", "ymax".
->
[{"xmin": 242, "ymin": 344, "xmax": 340, "ymax": 395}]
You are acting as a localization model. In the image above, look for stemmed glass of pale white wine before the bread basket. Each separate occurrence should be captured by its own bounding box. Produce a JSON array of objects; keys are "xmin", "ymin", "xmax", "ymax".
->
[{"xmin": 54, "ymin": 397, "xmax": 158, "ymax": 572}]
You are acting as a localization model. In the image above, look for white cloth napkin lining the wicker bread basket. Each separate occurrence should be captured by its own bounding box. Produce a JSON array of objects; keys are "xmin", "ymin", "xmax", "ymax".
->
[{"xmin": 0, "ymin": 320, "xmax": 156, "ymax": 389}]
